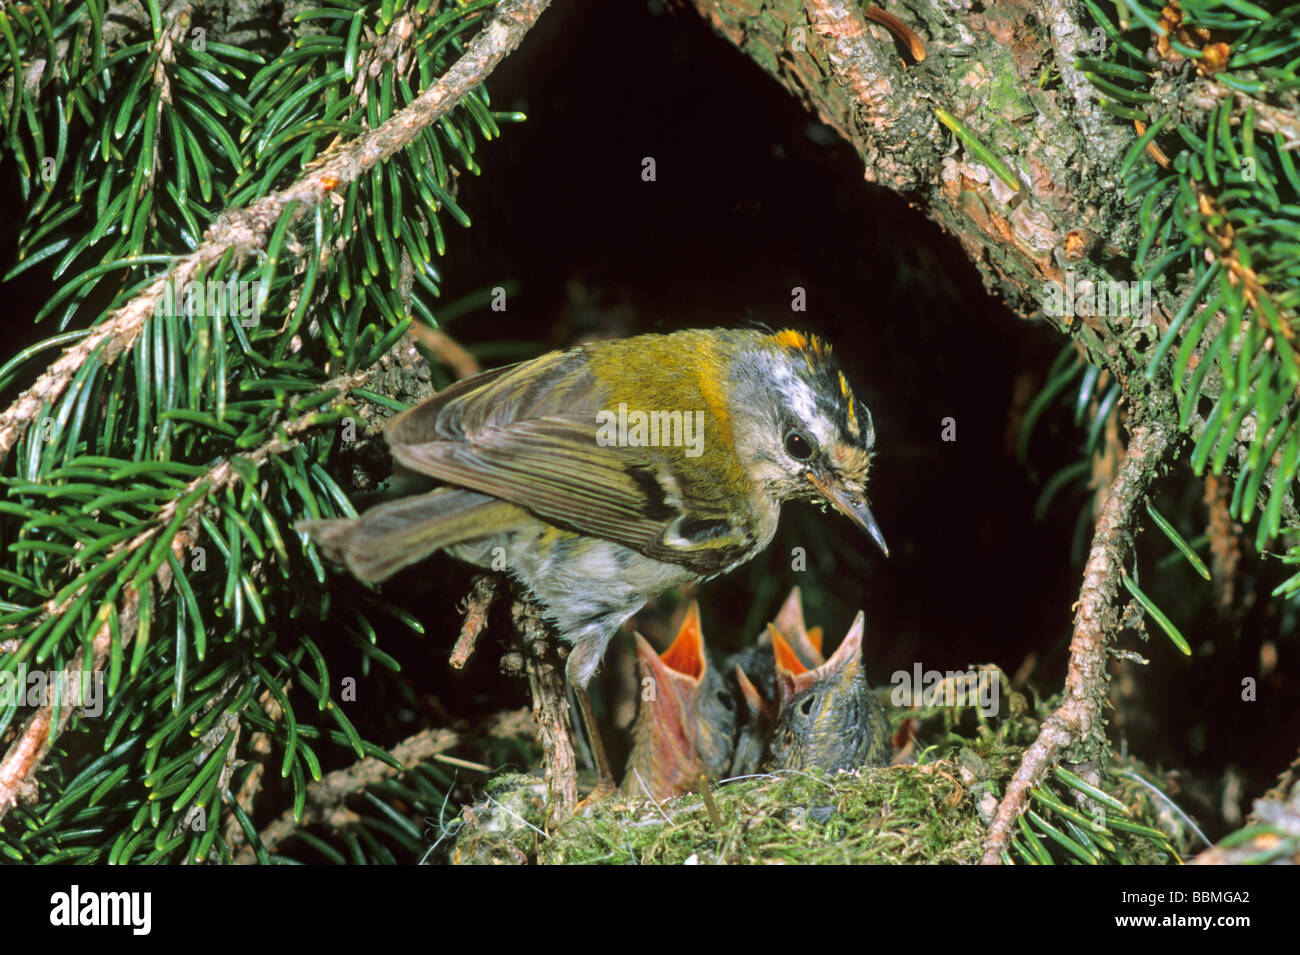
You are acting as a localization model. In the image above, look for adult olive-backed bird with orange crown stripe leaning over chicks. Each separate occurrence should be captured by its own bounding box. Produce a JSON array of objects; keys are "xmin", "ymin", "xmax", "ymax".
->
[{"xmin": 299, "ymin": 329, "xmax": 888, "ymax": 689}]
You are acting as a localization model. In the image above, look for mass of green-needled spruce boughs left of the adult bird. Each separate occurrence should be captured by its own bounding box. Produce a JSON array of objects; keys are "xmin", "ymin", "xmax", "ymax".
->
[{"xmin": 0, "ymin": 0, "xmax": 547, "ymax": 860}]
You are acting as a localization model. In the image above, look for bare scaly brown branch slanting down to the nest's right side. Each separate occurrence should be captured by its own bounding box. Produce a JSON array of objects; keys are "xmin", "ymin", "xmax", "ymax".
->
[{"xmin": 982, "ymin": 424, "xmax": 1170, "ymax": 865}]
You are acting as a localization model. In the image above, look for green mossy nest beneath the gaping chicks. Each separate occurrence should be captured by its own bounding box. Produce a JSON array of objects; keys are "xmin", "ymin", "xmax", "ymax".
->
[{"xmin": 447, "ymin": 696, "xmax": 1188, "ymax": 865}]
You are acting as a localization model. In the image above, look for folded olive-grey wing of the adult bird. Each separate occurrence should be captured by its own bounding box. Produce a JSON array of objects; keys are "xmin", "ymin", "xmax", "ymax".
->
[{"xmin": 386, "ymin": 348, "xmax": 753, "ymax": 573}]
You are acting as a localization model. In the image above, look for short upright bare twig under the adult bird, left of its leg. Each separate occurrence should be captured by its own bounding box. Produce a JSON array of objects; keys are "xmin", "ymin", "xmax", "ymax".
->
[{"xmin": 511, "ymin": 600, "xmax": 577, "ymax": 821}]
